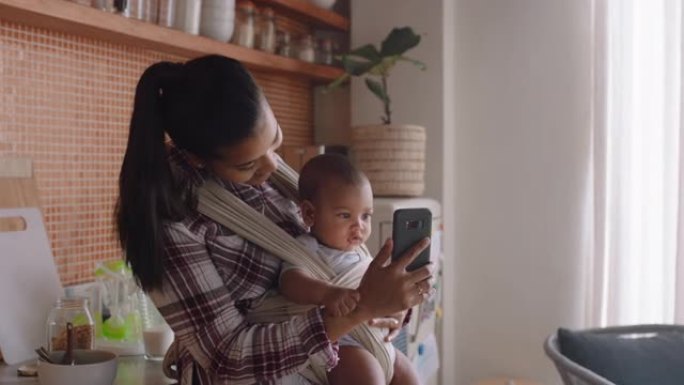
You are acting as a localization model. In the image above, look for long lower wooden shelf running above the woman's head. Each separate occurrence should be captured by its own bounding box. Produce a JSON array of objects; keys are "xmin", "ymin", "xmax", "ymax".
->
[{"xmin": 0, "ymin": 0, "xmax": 343, "ymax": 82}]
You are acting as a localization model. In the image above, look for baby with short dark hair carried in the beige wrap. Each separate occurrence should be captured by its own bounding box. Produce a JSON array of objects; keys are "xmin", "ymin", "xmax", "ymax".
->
[{"xmin": 280, "ymin": 154, "xmax": 420, "ymax": 385}]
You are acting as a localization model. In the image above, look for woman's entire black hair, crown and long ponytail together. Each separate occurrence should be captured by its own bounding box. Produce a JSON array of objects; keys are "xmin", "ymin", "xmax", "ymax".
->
[{"xmin": 115, "ymin": 55, "xmax": 263, "ymax": 291}]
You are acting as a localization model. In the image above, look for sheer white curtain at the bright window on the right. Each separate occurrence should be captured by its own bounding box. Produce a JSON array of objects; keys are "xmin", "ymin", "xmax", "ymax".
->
[{"xmin": 588, "ymin": 0, "xmax": 684, "ymax": 326}]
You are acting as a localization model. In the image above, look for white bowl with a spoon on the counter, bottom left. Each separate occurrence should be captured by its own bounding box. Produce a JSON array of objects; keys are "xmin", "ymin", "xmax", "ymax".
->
[{"xmin": 38, "ymin": 350, "xmax": 117, "ymax": 385}]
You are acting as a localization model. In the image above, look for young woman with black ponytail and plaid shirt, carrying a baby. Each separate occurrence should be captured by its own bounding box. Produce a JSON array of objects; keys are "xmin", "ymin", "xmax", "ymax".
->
[{"xmin": 116, "ymin": 55, "xmax": 430, "ymax": 385}]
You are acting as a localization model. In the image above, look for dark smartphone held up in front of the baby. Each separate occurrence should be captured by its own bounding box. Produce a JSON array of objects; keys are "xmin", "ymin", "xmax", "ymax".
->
[{"xmin": 392, "ymin": 208, "xmax": 432, "ymax": 271}]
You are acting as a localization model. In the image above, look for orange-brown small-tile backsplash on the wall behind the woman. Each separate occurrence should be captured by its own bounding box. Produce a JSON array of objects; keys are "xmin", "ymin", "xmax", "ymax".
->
[{"xmin": 0, "ymin": 16, "xmax": 313, "ymax": 285}]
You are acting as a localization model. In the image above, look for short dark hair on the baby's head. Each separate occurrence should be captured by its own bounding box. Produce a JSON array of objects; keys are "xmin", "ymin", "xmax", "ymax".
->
[{"xmin": 299, "ymin": 154, "xmax": 368, "ymax": 201}]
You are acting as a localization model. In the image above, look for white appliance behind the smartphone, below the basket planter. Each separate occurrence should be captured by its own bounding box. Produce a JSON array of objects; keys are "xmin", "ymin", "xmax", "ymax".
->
[{"xmin": 366, "ymin": 198, "xmax": 442, "ymax": 384}]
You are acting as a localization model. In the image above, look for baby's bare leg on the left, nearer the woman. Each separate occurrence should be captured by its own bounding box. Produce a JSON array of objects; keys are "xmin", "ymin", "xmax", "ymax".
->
[{"xmin": 328, "ymin": 346, "xmax": 385, "ymax": 385}]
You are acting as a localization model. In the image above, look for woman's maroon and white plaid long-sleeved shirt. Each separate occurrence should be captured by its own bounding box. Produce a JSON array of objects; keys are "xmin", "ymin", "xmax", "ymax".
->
[{"xmin": 151, "ymin": 150, "xmax": 337, "ymax": 385}]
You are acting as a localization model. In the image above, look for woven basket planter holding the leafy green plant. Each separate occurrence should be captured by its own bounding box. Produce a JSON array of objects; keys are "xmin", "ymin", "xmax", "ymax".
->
[{"xmin": 352, "ymin": 125, "xmax": 426, "ymax": 196}]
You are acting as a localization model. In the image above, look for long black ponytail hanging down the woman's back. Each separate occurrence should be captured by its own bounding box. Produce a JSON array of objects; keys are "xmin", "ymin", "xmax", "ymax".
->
[{"xmin": 116, "ymin": 62, "xmax": 186, "ymax": 291}]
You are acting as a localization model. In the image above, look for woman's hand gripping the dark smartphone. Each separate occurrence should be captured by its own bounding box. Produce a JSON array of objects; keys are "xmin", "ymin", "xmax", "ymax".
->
[{"xmin": 354, "ymin": 238, "xmax": 432, "ymax": 321}]
